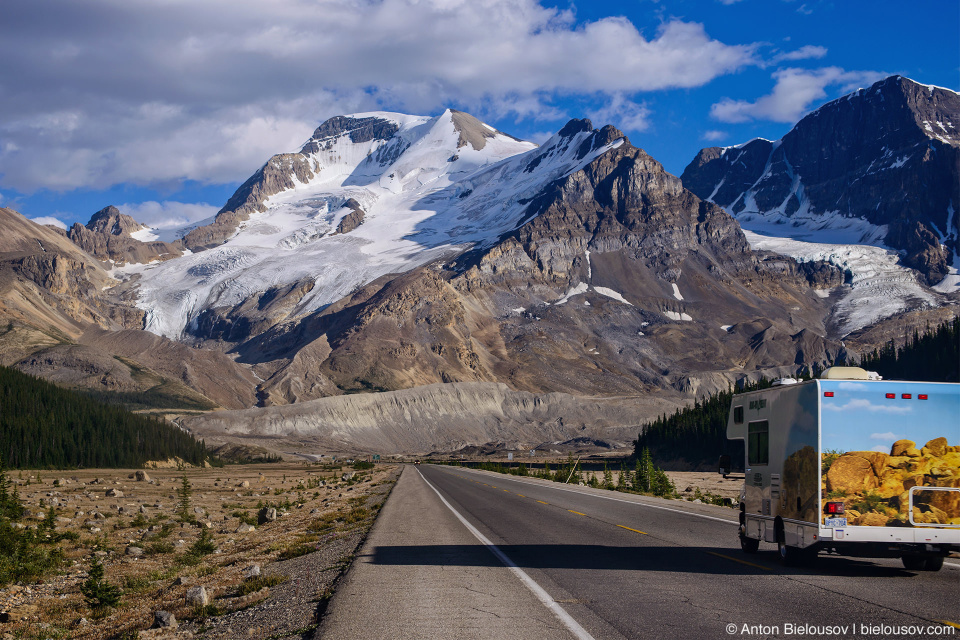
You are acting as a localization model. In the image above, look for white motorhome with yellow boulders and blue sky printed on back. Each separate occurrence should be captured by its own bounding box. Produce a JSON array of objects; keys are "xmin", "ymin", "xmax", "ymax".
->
[{"xmin": 720, "ymin": 367, "xmax": 960, "ymax": 571}]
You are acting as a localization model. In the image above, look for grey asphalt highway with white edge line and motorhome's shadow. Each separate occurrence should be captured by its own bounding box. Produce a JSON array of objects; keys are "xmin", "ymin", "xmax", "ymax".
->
[{"xmin": 316, "ymin": 465, "xmax": 960, "ymax": 639}]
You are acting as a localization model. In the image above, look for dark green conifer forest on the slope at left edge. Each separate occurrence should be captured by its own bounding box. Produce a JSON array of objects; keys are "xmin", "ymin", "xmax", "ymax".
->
[{"xmin": 0, "ymin": 367, "xmax": 207, "ymax": 468}]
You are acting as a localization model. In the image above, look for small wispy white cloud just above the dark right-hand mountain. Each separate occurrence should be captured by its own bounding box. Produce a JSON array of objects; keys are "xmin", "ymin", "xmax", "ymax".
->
[{"xmin": 710, "ymin": 67, "xmax": 884, "ymax": 123}]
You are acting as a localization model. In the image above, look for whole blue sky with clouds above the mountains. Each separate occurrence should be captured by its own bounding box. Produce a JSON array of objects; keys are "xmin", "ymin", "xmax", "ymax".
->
[{"xmin": 0, "ymin": 0, "xmax": 960, "ymax": 228}]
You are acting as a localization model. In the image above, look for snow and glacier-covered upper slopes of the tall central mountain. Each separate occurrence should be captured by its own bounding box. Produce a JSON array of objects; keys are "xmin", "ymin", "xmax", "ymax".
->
[{"xmin": 124, "ymin": 110, "xmax": 622, "ymax": 338}]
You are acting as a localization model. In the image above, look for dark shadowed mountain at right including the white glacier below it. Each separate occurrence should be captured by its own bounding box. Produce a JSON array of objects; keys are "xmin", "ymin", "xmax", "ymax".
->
[{"xmin": 681, "ymin": 76, "xmax": 960, "ymax": 333}]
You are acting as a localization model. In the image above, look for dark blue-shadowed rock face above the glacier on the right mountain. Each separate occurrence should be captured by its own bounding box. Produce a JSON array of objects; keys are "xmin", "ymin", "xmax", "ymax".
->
[{"xmin": 681, "ymin": 76, "xmax": 960, "ymax": 284}]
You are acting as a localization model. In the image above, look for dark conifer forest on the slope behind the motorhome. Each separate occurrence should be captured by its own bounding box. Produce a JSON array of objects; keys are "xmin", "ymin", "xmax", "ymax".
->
[{"xmin": 633, "ymin": 318, "xmax": 960, "ymax": 468}]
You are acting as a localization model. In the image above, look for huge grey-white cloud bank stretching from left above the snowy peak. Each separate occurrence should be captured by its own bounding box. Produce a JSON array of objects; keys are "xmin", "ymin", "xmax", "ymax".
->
[{"xmin": 0, "ymin": 0, "xmax": 757, "ymax": 192}]
